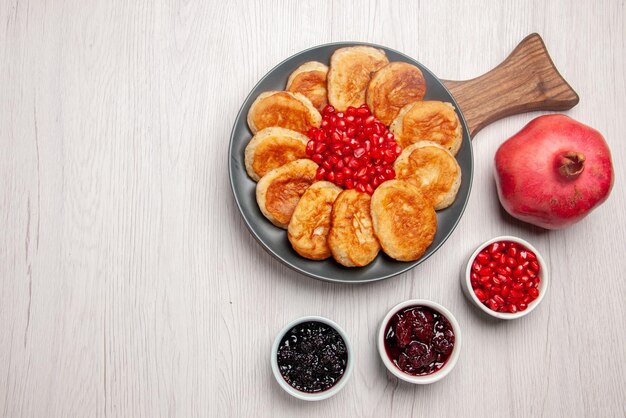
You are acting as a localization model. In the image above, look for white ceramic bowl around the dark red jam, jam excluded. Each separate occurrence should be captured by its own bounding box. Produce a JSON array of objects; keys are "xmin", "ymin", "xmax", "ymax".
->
[{"xmin": 378, "ymin": 299, "xmax": 461, "ymax": 385}]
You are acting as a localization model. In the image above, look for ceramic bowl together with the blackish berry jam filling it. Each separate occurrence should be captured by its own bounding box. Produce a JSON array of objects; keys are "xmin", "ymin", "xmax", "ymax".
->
[{"xmin": 271, "ymin": 316, "xmax": 354, "ymax": 401}]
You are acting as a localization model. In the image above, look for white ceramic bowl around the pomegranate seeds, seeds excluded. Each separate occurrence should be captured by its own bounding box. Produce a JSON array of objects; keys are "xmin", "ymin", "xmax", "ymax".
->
[{"xmin": 461, "ymin": 235, "xmax": 550, "ymax": 319}]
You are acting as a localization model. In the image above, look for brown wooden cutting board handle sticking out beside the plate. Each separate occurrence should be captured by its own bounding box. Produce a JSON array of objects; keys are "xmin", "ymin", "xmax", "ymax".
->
[{"xmin": 443, "ymin": 33, "xmax": 579, "ymax": 137}]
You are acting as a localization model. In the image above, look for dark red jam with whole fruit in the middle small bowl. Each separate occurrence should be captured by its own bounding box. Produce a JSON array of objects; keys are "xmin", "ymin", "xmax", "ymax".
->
[{"xmin": 385, "ymin": 306, "xmax": 454, "ymax": 376}]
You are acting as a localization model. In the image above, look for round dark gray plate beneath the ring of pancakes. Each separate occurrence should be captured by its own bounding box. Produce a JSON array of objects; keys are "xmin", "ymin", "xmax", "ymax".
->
[{"xmin": 228, "ymin": 42, "xmax": 473, "ymax": 283}]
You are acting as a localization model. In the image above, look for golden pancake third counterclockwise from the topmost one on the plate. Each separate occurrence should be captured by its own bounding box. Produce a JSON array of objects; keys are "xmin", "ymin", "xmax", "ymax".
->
[{"xmin": 245, "ymin": 128, "xmax": 309, "ymax": 181}]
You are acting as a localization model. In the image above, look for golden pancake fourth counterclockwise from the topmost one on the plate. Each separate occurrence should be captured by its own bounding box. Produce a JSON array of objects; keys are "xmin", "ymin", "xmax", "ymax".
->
[{"xmin": 256, "ymin": 159, "xmax": 317, "ymax": 229}]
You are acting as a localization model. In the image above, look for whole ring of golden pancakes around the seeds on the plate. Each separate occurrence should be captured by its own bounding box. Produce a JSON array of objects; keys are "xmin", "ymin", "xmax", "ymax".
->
[{"xmin": 245, "ymin": 46, "xmax": 462, "ymax": 267}]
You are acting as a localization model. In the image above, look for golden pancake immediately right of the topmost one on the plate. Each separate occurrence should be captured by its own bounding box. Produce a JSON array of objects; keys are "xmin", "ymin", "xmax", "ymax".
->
[{"xmin": 367, "ymin": 62, "xmax": 426, "ymax": 126}]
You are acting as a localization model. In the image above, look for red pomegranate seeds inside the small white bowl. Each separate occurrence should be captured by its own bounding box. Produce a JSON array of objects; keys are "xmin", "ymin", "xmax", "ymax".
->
[{"xmin": 470, "ymin": 241, "xmax": 539, "ymax": 313}]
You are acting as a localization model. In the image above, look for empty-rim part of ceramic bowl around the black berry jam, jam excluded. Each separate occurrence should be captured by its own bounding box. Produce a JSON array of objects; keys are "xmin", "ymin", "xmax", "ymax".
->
[{"xmin": 271, "ymin": 316, "xmax": 355, "ymax": 401}]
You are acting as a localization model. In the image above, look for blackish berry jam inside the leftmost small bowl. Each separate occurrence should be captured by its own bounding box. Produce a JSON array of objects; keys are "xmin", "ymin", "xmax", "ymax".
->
[{"xmin": 278, "ymin": 321, "xmax": 348, "ymax": 393}]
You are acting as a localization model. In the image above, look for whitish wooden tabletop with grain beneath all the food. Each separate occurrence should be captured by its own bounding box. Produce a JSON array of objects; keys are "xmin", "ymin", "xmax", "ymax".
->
[{"xmin": 0, "ymin": 0, "xmax": 626, "ymax": 417}]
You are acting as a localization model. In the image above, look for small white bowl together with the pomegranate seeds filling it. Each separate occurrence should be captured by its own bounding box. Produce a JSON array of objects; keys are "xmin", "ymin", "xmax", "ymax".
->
[{"xmin": 461, "ymin": 236, "xmax": 549, "ymax": 319}]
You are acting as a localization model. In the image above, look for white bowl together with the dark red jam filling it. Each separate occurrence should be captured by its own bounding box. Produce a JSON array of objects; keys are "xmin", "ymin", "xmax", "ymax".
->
[{"xmin": 378, "ymin": 299, "xmax": 461, "ymax": 384}]
